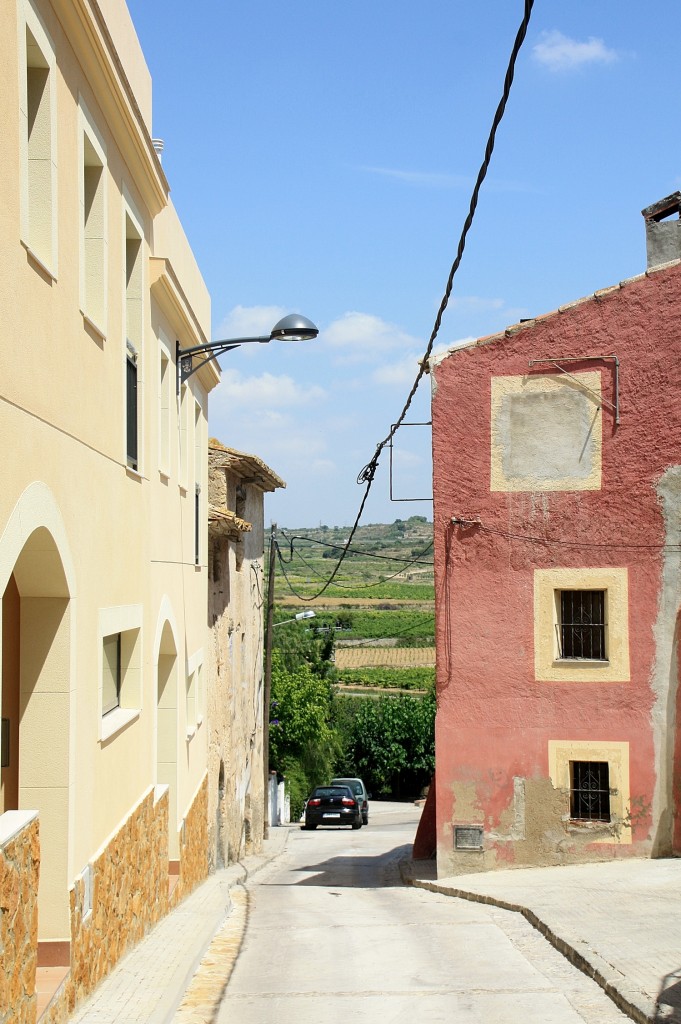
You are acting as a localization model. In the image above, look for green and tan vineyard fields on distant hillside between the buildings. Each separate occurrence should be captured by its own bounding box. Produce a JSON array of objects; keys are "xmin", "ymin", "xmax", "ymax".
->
[{"xmin": 274, "ymin": 516, "xmax": 435, "ymax": 695}]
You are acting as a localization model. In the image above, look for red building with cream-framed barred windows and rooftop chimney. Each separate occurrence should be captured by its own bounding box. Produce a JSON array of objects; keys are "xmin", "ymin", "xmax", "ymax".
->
[{"xmin": 431, "ymin": 193, "xmax": 681, "ymax": 877}]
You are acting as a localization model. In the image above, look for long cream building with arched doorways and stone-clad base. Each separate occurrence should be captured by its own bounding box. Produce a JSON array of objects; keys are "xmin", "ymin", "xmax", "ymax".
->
[{"xmin": 0, "ymin": 0, "xmax": 218, "ymax": 1021}]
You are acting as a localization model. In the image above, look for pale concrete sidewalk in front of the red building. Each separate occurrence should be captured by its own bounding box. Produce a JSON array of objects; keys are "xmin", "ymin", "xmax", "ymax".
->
[{"xmin": 402, "ymin": 859, "xmax": 681, "ymax": 1024}]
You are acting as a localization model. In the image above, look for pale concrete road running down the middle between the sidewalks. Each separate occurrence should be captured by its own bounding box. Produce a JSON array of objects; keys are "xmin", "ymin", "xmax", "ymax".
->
[{"xmin": 218, "ymin": 802, "xmax": 629, "ymax": 1024}]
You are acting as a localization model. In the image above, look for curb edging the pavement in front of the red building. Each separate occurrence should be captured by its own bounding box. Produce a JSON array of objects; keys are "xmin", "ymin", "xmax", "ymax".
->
[{"xmin": 399, "ymin": 860, "xmax": 659, "ymax": 1024}]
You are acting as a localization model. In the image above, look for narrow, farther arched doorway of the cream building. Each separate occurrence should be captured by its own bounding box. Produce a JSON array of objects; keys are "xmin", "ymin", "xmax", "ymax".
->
[{"xmin": 156, "ymin": 621, "xmax": 179, "ymax": 861}]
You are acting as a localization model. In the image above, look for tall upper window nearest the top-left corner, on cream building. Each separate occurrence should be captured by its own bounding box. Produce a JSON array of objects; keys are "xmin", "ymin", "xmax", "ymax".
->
[{"xmin": 20, "ymin": 3, "xmax": 56, "ymax": 272}]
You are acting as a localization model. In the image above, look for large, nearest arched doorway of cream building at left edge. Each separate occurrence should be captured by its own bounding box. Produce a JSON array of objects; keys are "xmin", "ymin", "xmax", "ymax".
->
[{"xmin": 0, "ymin": 524, "xmax": 72, "ymax": 941}]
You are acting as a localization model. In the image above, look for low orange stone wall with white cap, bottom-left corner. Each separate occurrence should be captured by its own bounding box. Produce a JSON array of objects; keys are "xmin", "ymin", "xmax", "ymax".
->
[{"xmin": 0, "ymin": 811, "xmax": 40, "ymax": 1024}]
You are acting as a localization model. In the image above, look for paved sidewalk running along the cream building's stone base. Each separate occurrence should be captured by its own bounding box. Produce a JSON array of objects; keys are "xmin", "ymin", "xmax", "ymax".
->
[{"xmin": 69, "ymin": 825, "xmax": 290, "ymax": 1024}]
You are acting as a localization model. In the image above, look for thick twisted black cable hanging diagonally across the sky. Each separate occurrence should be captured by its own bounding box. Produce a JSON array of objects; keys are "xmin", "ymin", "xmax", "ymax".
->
[{"xmin": 287, "ymin": 0, "xmax": 535, "ymax": 601}]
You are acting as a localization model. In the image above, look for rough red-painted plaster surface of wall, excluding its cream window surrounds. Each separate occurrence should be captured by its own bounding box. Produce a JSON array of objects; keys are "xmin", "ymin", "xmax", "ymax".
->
[{"xmin": 432, "ymin": 265, "xmax": 681, "ymax": 874}]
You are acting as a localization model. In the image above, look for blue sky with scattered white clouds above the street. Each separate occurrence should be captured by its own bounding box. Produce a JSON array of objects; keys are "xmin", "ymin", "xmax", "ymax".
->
[{"xmin": 129, "ymin": 0, "xmax": 681, "ymax": 526}]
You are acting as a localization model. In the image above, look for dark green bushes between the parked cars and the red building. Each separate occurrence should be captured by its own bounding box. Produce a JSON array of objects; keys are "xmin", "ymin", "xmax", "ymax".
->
[{"xmin": 337, "ymin": 693, "xmax": 435, "ymax": 800}]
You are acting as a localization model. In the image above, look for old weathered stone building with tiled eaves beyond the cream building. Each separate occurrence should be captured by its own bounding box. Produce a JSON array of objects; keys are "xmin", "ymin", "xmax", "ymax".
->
[{"xmin": 207, "ymin": 439, "xmax": 286, "ymax": 867}]
